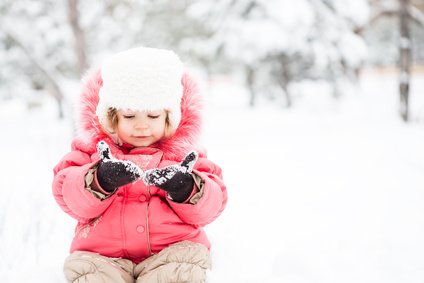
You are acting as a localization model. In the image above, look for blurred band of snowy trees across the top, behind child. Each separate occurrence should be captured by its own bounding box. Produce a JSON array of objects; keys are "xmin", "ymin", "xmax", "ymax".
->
[{"xmin": 0, "ymin": 0, "xmax": 424, "ymax": 121}]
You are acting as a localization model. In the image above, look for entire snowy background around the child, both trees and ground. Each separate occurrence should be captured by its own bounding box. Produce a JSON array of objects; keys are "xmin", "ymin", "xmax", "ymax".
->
[{"xmin": 0, "ymin": 0, "xmax": 424, "ymax": 283}]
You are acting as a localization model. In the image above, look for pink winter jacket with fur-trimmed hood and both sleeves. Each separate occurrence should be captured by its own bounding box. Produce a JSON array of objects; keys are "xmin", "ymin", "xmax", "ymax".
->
[{"xmin": 53, "ymin": 72, "xmax": 227, "ymax": 263}]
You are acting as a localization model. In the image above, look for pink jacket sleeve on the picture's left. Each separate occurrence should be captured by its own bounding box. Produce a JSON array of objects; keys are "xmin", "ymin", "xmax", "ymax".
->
[{"xmin": 52, "ymin": 142, "xmax": 114, "ymax": 223}]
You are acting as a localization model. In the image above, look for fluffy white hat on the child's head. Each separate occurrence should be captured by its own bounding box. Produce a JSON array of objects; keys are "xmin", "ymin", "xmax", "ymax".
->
[{"xmin": 96, "ymin": 47, "xmax": 184, "ymax": 135}]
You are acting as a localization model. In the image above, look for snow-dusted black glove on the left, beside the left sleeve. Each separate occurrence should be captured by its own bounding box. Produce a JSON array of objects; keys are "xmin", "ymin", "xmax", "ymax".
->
[{"xmin": 97, "ymin": 141, "xmax": 143, "ymax": 192}]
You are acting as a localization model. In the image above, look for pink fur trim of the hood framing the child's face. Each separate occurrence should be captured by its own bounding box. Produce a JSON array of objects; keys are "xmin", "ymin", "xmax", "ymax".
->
[{"xmin": 73, "ymin": 70, "xmax": 206, "ymax": 161}]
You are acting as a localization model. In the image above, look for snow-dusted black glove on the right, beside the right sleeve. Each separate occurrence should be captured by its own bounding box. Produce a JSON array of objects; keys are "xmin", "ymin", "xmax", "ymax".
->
[{"xmin": 143, "ymin": 151, "xmax": 198, "ymax": 202}]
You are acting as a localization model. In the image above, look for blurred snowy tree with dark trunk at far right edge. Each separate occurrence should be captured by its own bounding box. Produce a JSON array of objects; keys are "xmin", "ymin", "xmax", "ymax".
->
[{"xmin": 364, "ymin": 0, "xmax": 424, "ymax": 121}]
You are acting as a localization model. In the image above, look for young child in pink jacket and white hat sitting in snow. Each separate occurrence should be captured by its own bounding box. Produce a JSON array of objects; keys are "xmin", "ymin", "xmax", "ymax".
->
[{"xmin": 53, "ymin": 47, "xmax": 227, "ymax": 283}]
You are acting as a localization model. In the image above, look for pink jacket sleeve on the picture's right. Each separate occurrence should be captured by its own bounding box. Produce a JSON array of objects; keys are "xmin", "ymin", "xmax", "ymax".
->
[{"xmin": 169, "ymin": 158, "xmax": 227, "ymax": 229}]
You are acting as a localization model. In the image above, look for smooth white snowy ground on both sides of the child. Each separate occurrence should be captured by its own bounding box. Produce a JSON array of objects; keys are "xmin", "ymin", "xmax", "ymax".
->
[{"xmin": 0, "ymin": 71, "xmax": 424, "ymax": 283}]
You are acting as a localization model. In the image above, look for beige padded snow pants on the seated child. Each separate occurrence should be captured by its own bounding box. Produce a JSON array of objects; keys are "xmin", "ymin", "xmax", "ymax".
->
[{"xmin": 63, "ymin": 241, "xmax": 211, "ymax": 283}]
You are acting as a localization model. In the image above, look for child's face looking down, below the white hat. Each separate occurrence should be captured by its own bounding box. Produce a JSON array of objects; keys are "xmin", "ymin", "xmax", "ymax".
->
[{"xmin": 116, "ymin": 110, "xmax": 167, "ymax": 147}]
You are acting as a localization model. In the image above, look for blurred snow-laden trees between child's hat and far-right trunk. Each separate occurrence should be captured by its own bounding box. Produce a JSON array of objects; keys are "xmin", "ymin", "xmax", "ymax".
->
[{"xmin": 185, "ymin": 0, "xmax": 368, "ymax": 106}]
